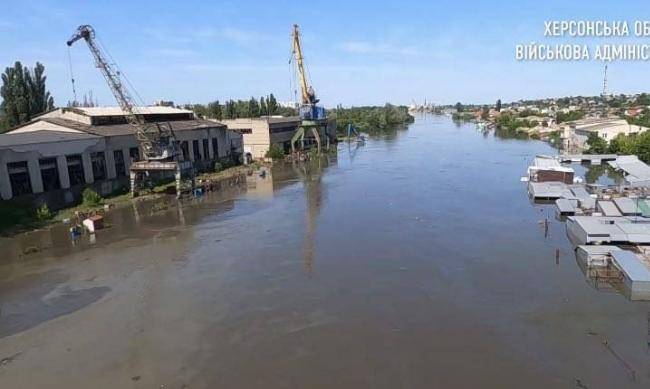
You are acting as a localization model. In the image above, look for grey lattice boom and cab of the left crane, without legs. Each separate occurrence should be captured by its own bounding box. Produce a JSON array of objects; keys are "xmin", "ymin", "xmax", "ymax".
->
[{"xmin": 67, "ymin": 25, "xmax": 178, "ymax": 160}]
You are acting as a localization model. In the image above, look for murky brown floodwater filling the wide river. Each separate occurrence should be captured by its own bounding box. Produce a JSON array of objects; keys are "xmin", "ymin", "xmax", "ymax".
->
[{"xmin": 0, "ymin": 113, "xmax": 650, "ymax": 389}]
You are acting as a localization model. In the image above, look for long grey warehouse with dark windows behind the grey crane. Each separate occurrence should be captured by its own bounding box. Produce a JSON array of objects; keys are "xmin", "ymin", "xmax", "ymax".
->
[{"xmin": 0, "ymin": 106, "xmax": 242, "ymax": 207}]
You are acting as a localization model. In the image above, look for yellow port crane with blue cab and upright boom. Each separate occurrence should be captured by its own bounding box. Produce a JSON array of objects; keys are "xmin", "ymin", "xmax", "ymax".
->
[{"xmin": 291, "ymin": 24, "xmax": 329, "ymax": 155}]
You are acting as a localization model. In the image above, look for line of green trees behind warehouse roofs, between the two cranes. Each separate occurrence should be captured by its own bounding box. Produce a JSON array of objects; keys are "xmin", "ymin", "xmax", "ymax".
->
[{"xmin": 185, "ymin": 93, "xmax": 297, "ymax": 120}]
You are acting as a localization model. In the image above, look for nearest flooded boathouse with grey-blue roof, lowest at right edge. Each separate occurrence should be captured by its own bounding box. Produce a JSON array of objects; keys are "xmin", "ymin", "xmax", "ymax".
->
[{"xmin": 611, "ymin": 250, "xmax": 650, "ymax": 300}]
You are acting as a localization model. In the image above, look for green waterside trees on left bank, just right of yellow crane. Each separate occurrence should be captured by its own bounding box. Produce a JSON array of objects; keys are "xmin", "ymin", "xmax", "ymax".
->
[{"xmin": 329, "ymin": 104, "xmax": 414, "ymax": 134}]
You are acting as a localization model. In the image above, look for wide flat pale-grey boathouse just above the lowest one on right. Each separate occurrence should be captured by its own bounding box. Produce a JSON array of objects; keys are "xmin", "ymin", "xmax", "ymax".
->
[{"xmin": 567, "ymin": 216, "xmax": 650, "ymax": 245}]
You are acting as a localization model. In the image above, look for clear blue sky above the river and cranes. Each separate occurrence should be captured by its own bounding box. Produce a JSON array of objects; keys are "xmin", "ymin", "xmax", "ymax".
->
[{"xmin": 0, "ymin": 0, "xmax": 650, "ymax": 106}]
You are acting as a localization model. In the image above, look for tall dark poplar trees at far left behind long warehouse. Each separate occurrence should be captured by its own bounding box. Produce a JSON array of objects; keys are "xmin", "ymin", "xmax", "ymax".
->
[{"xmin": 0, "ymin": 62, "xmax": 54, "ymax": 132}]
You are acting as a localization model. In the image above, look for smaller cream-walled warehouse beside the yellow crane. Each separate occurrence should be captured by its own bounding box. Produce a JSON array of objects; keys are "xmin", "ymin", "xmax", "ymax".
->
[{"xmin": 220, "ymin": 116, "xmax": 336, "ymax": 160}]
